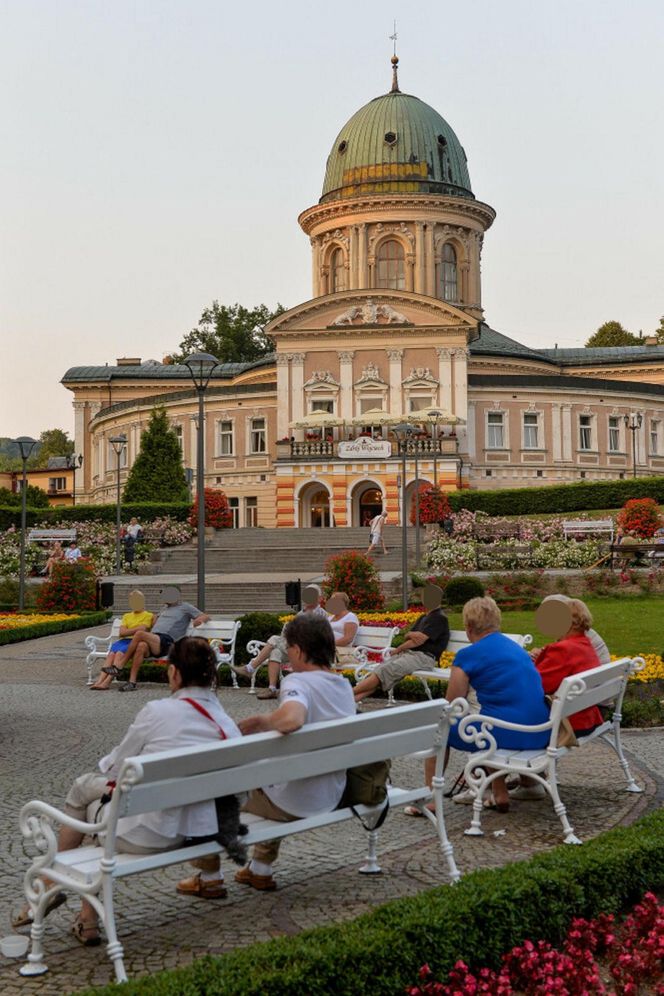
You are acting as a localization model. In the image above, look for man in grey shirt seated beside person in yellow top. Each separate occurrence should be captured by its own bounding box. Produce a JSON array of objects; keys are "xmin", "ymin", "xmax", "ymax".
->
[{"xmin": 102, "ymin": 585, "xmax": 210, "ymax": 692}]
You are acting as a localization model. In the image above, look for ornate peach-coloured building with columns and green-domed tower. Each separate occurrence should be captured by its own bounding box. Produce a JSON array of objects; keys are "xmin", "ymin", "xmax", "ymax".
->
[{"xmin": 63, "ymin": 57, "xmax": 664, "ymax": 527}]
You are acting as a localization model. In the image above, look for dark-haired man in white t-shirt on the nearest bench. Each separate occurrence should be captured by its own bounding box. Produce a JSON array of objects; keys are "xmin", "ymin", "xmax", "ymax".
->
[{"xmin": 178, "ymin": 613, "xmax": 355, "ymax": 892}]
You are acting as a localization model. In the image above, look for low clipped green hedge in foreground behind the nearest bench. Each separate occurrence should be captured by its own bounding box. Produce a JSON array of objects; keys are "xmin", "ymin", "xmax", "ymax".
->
[{"xmin": 78, "ymin": 810, "xmax": 664, "ymax": 996}]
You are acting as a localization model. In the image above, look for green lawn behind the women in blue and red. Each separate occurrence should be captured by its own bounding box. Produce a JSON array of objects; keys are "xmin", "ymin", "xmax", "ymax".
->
[{"xmin": 449, "ymin": 595, "xmax": 664, "ymax": 655}]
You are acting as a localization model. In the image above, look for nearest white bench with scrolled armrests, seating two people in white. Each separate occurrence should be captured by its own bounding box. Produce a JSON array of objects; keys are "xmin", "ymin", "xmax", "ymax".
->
[{"xmin": 20, "ymin": 699, "xmax": 467, "ymax": 982}]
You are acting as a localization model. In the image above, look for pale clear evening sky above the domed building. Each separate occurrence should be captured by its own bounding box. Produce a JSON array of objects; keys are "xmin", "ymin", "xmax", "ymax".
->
[{"xmin": 0, "ymin": 0, "xmax": 664, "ymax": 436}]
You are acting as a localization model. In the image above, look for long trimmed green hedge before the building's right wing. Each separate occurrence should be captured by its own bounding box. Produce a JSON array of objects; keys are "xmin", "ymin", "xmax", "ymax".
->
[{"xmin": 447, "ymin": 476, "xmax": 664, "ymax": 515}]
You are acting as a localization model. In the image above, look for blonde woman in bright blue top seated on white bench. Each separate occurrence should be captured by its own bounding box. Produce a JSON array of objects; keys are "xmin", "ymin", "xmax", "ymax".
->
[{"xmin": 412, "ymin": 598, "xmax": 549, "ymax": 815}]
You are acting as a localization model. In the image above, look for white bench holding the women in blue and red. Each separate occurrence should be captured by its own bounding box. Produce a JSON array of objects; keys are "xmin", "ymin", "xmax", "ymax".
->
[{"xmin": 459, "ymin": 657, "xmax": 645, "ymax": 844}]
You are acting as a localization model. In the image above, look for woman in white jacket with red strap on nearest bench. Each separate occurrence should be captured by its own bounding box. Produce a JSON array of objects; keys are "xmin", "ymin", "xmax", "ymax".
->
[{"xmin": 13, "ymin": 637, "xmax": 240, "ymax": 947}]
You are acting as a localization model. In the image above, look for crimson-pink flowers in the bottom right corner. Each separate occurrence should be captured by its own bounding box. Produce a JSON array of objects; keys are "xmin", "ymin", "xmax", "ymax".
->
[{"xmin": 406, "ymin": 892, "xmax": 664, "ymax": 996}]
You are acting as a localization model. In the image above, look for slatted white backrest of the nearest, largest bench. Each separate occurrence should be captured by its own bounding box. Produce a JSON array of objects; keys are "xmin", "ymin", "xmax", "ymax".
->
[{"xmin": 109, "ymin": 699, "xmax": 466, "ymax": 817}]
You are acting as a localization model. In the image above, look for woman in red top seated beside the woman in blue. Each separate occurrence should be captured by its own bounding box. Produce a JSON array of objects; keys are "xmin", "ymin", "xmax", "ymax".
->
[{"xmin": 534, "ymin": 598, "xmax": 603, "ymax": 735}]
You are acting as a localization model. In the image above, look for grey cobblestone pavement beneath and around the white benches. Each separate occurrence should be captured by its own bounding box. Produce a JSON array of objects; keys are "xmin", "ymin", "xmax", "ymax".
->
[{"xmin": 0, "ymin": 629, "xmax": 664, "ymax": 996}]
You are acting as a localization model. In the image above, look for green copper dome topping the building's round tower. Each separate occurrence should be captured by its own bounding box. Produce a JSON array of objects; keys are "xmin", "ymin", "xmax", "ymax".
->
[{"xmin": 320, "ymin": 76, "xmax": 473, "ymax": 204}]
